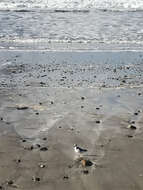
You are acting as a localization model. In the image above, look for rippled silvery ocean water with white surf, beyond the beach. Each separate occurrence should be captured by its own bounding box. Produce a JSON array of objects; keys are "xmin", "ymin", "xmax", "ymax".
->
[{"xmin": 0, "ymin": 0, "xmax": 143, "ymax": 51}]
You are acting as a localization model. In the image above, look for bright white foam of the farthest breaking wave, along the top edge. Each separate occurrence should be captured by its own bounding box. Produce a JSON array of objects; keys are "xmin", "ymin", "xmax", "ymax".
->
[{"xmin": 0, "ymin": 0, "xmax": 143, "ymax": 10}]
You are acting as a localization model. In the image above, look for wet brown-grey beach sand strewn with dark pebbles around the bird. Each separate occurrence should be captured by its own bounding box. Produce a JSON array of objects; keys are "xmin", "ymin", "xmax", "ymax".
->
[{"xmin": 0, "ymin": 52, "xmax": 143, "ymax": 190}]
